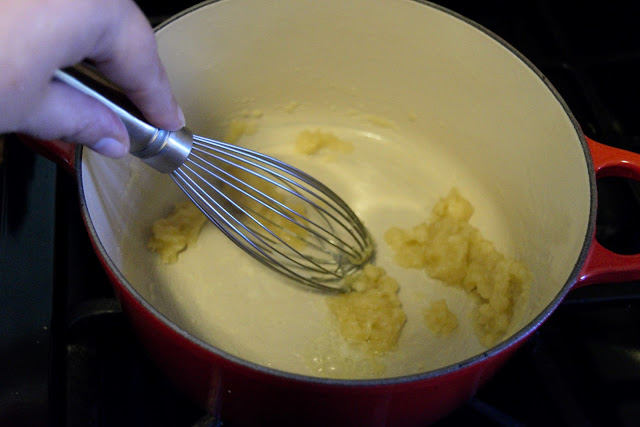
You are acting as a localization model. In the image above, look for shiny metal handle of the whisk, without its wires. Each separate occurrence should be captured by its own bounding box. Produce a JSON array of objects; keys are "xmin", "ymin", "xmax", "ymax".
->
[{"xmin": 54, "ymin": 65, "xmax": 193, "ymax": 173}]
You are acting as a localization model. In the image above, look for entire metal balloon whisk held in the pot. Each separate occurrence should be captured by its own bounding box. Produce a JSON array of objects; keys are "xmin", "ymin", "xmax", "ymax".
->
[{"xmin": 54, "ymin": 65, "xmax": 374, "ymax": 293}]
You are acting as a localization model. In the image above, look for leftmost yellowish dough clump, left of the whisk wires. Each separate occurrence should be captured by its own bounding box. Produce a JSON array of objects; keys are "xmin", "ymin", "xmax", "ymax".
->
[{"xmin": 147, "ymin": 202, "xmax": 207, "ymax": 264}]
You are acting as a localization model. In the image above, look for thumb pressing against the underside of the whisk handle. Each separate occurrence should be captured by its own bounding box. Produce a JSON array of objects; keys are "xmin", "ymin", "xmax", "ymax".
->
[{"xmin": 19, "ymin": 80, "xmax": 129, "ymax": 158}]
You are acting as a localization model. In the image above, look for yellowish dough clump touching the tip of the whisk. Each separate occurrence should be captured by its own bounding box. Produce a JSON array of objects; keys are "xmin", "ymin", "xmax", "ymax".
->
[{"xmin": 327, "ymin": 264, "xmax": 407, "ymax": 355}]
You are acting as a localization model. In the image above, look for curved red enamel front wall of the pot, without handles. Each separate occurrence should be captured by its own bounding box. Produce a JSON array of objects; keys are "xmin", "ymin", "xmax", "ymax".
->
[{"xmin": 95, "ymin": 252, "xmax": 524, "ymax": 426}]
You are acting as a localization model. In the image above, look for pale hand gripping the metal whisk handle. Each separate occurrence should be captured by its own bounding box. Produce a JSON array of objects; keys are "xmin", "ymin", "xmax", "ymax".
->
[{"xmin": 0, "ymin": 0, "xmax": 184, "ymax": 158}]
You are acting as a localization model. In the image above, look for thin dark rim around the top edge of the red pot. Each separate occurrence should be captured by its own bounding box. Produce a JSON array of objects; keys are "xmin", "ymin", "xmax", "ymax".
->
[{"xmin": 76, "ymin": 0, "xmax": 597, "ymax": 387}]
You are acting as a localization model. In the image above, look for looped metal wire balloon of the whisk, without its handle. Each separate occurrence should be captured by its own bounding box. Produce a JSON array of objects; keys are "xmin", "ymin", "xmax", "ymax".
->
[{"xmin": 171, "ymin": 136, "xmax": 373, "ymax": 292}]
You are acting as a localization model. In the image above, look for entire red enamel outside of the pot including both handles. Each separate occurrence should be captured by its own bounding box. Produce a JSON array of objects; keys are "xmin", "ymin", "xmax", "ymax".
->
[{"xmin": 23, "ymin": 130, "xmax": 640, "ymax": 426}]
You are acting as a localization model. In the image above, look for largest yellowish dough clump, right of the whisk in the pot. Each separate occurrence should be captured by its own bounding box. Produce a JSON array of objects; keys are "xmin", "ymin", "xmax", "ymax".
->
[{"xmin": 385, "ymin": 188, "xmax": 531, "ymax": 347}]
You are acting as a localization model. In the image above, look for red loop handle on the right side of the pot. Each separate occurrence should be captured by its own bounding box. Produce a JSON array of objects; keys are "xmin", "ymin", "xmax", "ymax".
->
[{"xmin": 574, "ymin": 137, "xmax": 640, "ymax": 288}]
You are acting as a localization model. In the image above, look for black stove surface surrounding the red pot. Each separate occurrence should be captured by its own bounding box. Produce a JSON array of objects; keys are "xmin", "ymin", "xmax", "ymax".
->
[{"xmin": 0, "ymin": 0, "xmax": 640, "ymax": 426}]
